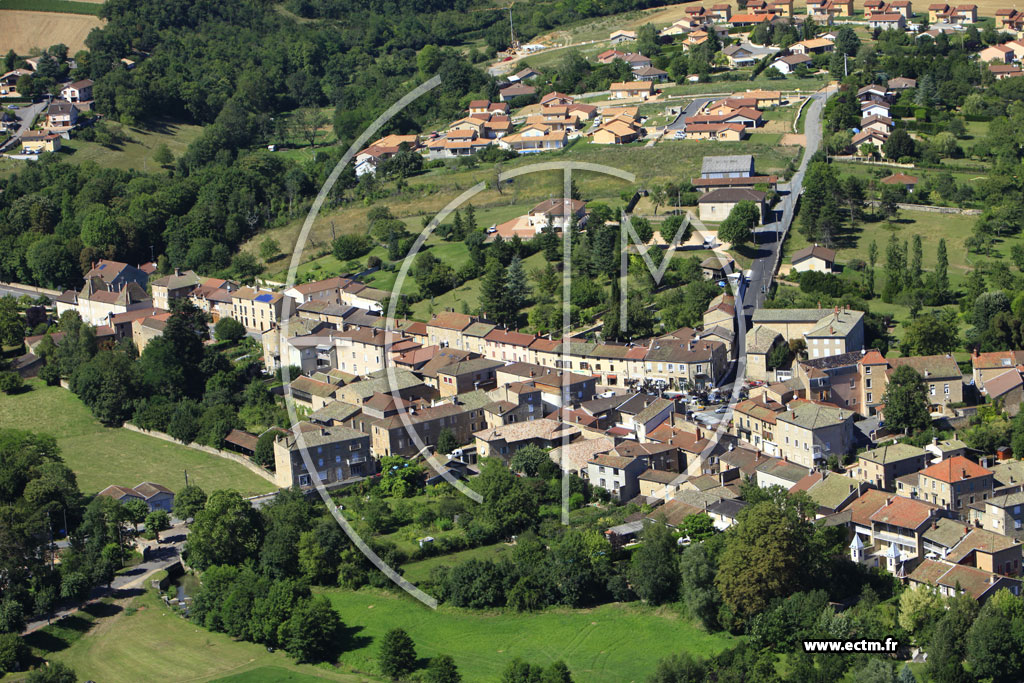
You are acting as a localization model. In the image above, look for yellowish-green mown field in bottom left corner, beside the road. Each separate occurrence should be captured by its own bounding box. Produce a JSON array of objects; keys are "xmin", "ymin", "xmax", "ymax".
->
[{"xmin": 12, "ymin": 590, "xmax": 368, "ymax": 683}]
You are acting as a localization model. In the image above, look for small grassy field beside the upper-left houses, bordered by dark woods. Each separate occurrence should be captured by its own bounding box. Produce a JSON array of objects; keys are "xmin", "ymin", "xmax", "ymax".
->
[{"xmin": 58, "ymin": 117, "xmax": 203, "ymax": 173}]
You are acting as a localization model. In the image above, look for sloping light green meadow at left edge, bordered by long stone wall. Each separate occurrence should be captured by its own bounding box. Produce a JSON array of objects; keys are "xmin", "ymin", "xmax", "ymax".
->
[{"xmin": 0, "ymin": 380, "xmax": 275, "ymax": 496}]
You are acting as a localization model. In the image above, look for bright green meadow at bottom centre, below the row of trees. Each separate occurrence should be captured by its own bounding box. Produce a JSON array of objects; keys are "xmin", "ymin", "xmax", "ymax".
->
[{"xmin": 327, "ymin": 589, "xmax": 737, "ymax": 683}]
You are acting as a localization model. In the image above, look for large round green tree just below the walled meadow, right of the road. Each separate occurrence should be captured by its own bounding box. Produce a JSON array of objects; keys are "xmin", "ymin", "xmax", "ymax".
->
[{"xmin": 184, "ymin": 490, "xmax": 262, "ymax": 570}]
